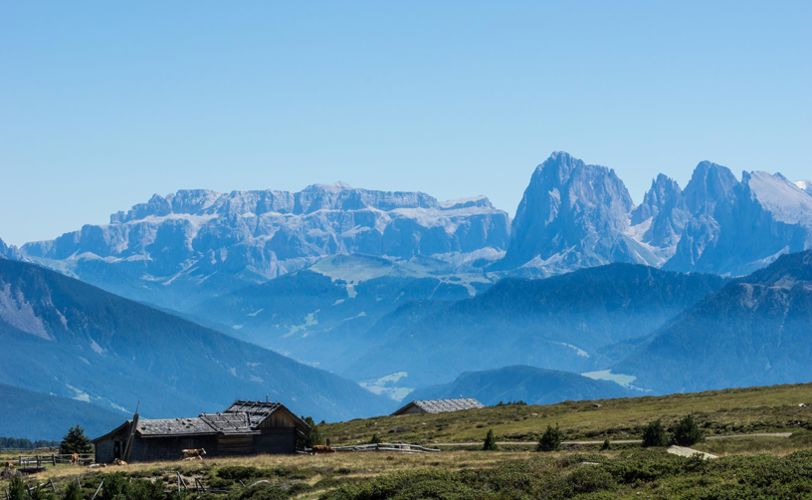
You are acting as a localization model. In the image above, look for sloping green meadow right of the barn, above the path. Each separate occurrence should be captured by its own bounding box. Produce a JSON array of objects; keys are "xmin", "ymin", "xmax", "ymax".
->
[{"xmin": 322, "ymin": 384, "xmax": 812, "ymax": 444}]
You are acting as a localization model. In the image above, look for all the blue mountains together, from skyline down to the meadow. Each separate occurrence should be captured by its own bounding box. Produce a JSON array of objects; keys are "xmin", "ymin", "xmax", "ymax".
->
[{"xmin": 0, "ymin": 152, "xmax": 812, "ymax": 433}]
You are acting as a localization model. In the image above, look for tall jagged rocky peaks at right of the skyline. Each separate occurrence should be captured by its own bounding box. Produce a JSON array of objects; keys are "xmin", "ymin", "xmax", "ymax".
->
[{"xmin": 493, "ymin": 153, "xmax": 812, "ymax": 276}]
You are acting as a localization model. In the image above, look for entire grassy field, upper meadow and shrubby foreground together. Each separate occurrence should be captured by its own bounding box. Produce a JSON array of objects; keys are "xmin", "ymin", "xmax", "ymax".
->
[{"xmin": 0, "ymin": 385, "xmax": 812, "ymax": 500}]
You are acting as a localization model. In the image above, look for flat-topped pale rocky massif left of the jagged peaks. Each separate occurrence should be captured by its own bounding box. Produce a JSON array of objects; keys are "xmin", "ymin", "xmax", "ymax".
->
[{"xmin": 22, "ymin": 184, "xmax": 510, "ymax": 309}]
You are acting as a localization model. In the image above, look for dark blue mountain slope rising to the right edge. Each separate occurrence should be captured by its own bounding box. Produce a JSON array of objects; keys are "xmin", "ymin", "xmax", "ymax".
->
[{"xmin": 614, "ymin": 251, "xmax": 812, "ymax": 392}]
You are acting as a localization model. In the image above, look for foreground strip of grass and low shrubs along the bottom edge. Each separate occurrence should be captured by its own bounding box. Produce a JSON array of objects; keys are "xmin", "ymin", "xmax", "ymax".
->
[{"xmin": 6, "ymin": 448, "xmax": 812, "ymax": 500}]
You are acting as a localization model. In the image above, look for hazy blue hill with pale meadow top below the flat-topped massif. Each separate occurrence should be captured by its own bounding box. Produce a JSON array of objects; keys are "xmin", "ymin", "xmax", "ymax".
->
[{"xmin": 191, "ymin": 256, "xmax": 490, "ymax": 370}]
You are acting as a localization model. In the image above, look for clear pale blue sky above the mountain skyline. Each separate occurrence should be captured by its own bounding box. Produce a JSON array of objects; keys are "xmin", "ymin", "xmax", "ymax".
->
[{"xmin": 0, "ymin": 0, "xmax": 812, "ymax": 244}]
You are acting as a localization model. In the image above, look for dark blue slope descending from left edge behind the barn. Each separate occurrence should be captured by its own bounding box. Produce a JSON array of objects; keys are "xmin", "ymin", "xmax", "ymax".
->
[{"xmin": 0, "ymin": 260, "xmax": 388, "ymax": 419}]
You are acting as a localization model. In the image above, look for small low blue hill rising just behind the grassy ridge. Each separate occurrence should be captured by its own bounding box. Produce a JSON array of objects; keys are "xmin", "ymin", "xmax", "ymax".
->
[{"xmin": 407, "ymin": 365, "xmax": 639, "ymax": 405}]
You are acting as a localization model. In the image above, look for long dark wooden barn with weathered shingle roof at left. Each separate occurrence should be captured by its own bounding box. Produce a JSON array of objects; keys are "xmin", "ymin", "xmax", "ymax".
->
[{"xmin": 93, "ymin": 401, "xmax": 309, "ymax": 463}]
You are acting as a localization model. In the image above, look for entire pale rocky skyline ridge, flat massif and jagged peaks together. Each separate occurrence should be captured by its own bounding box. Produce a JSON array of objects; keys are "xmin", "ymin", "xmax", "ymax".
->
[{"xmin": 14, "ymin": 152, "xmax": 812, "ymax": 312}]
